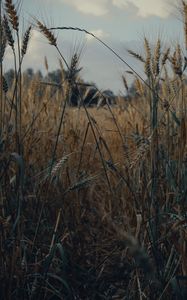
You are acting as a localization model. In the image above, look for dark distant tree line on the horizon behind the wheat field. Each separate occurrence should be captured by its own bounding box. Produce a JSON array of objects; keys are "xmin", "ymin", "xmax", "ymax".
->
[{"xmin": 4, "ymin": 68, "xmax": 116, "ymax": 106}]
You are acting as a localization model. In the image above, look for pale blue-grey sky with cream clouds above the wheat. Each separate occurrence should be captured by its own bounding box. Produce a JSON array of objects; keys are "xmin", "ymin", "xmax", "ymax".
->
[{"xmin": 5, "ymin": 0, "xmax": 183, "ymax": 92}]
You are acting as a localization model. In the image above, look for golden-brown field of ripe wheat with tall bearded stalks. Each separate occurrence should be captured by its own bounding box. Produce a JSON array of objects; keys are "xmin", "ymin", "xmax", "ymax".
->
[{"xmin": 0, "ymin": 0, "xmax": 187, "ymax": 300}]
